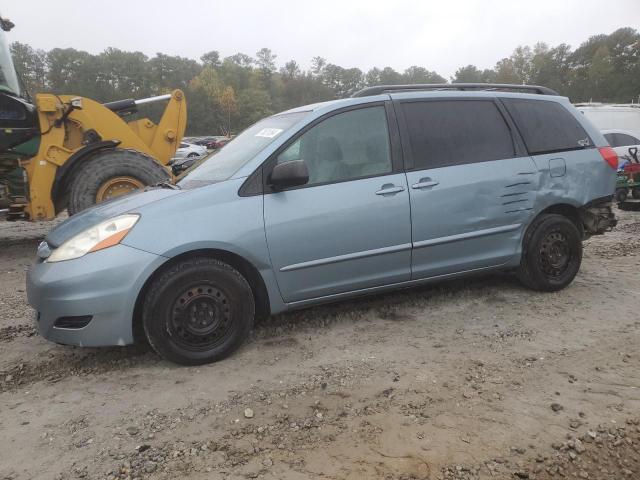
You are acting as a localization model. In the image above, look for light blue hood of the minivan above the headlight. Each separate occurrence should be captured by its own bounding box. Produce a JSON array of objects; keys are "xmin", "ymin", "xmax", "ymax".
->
[{"xmin": 45, "ymin": 188, "xmax": 182, "ymax": 248}]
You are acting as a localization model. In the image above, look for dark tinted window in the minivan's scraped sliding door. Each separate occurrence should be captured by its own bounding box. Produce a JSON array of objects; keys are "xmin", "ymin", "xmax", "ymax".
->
[{"xmin": 401, "ymin": 100, "xmax": 515, "ymax": 169}]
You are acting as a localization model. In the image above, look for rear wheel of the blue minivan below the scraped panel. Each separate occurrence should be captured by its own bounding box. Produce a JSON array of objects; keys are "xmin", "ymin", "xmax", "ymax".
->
[{"xmin": 518, "ymin": 214, "xmax": 582, "ymax": 292}]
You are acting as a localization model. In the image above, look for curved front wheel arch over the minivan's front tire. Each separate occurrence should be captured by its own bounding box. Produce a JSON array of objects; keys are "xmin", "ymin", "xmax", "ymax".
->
[{"xmin": 132, "ymin": 248, "xmax": 271, "ymax": 343}]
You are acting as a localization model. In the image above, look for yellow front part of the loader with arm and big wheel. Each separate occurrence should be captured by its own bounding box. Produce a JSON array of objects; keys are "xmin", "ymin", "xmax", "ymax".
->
[{"xmin": 20, "ymin": 90, "xmax": 187, "ymax": 220}]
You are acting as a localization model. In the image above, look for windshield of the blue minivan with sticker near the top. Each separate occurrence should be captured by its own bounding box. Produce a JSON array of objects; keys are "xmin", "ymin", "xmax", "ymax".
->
[{"xmin": 178, "ymin": 111, "xmax": 309, "ymax": 188}]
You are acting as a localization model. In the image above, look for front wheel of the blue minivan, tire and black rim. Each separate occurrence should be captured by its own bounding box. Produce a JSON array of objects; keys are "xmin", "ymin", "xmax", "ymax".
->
[{"xmin": 142, "ymin": 258, "xmax": 255, "ymax": 365}]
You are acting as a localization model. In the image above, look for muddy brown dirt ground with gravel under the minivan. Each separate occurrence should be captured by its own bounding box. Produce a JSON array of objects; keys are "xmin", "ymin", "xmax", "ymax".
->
[{"xmin": 0, "ymin": 212, "xmax": 640, "ymax": 480}]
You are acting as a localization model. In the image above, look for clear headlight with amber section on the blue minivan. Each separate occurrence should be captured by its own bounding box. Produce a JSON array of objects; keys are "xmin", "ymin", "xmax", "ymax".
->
[{"xmin": 46, "ymin": 214, "xmax": 140, "ymax": 262}]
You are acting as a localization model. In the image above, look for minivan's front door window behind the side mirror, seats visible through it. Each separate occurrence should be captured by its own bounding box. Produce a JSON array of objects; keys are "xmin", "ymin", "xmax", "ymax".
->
[{"xmin": 276, "ymin": 106, "xmax": 392, "ymax": 185}]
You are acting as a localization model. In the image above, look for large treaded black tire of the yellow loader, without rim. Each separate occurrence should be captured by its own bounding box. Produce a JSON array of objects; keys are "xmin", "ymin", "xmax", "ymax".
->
[{"xmin": 67, "ymin": 149, "xmax": 171, "ymax": 215}]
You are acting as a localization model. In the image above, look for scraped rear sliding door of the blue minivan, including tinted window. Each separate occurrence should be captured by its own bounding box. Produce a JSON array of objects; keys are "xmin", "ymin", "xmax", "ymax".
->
[{"xmin": 398, "ymin": 98, "xmax": 539, "ymax": 279}]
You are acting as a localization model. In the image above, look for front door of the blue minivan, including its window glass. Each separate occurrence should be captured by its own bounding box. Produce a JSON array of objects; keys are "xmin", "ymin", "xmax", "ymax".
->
[{"xmin": 264, "ymin": 104, "xmax": 411, "ymax": 302}]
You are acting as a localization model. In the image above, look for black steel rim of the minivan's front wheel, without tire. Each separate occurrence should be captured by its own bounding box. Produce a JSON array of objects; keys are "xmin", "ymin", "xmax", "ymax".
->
[{"xmin": 167, "ymin": 283, "xmax": 233, "ymax": 351}]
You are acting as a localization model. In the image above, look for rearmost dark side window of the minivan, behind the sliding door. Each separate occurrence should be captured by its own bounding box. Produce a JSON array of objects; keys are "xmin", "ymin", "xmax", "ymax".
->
[{"xmin": 502, "ymin": 98, "xmax": 592, "ymax": 155}]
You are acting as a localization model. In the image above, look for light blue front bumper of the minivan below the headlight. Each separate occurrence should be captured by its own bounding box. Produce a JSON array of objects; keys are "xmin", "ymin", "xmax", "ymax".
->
[{"xmin": 27, "ymin": 245, "xmax": 166, "ymax": 347}]
